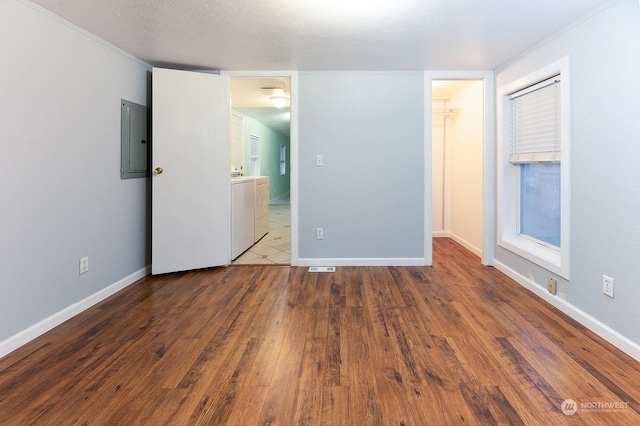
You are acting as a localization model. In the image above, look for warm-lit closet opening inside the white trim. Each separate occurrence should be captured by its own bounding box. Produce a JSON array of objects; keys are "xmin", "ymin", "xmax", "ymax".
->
[{"xmin": 431, "ymin": 80, "xmax": 483, "ymax": 256}]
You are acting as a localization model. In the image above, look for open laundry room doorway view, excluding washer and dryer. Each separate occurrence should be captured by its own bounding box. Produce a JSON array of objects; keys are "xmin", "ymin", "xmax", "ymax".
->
[{"xmin": 231, "ymin": 75, "xmax": 292, "ymax": 265}]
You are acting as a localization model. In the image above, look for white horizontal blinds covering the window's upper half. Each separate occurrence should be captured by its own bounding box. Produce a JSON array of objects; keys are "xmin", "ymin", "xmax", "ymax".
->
[{"xmin": 509, "ymin": 75, "xmax": 561, "ymax": 164}]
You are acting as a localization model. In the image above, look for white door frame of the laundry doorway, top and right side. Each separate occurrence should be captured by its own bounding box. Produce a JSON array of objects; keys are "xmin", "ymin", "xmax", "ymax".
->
[{"xmin": 220, "ymin": 70, "xmax": 299, "ymax": 266}]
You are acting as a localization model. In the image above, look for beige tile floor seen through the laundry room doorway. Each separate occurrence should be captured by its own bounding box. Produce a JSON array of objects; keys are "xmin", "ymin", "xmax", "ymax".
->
[{"xmin": 232, "ymin": 204, "xmax": 291, "ymax": 265}]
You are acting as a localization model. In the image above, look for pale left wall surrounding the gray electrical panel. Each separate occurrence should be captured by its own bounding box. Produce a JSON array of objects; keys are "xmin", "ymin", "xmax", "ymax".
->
[{"xmin": 0, "ymin": 0, "xmax": 150, "ymax": 355}]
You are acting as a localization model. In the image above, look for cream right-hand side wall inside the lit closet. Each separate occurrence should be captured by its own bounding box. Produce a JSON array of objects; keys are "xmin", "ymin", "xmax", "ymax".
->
[{"xmin": 450, "ymin": 80, "xmax": 484, "ymax": 256}]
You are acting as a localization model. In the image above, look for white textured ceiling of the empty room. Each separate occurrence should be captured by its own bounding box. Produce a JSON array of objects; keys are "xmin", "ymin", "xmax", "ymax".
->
[{"xmin": 35, "ymin": 0, "xmax": 608, "ymax": 70}]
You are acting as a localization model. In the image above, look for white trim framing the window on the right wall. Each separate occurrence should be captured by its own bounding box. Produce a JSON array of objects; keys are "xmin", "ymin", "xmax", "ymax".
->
[{"xmin": 496, "ymin": 57, "xmax": 571, "ymax": 279}]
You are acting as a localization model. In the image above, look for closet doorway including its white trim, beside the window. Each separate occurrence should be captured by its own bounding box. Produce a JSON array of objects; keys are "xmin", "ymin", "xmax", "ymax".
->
[{"xmin": 425, "ymin": 71, "xmax": 495, "ymax": 265}]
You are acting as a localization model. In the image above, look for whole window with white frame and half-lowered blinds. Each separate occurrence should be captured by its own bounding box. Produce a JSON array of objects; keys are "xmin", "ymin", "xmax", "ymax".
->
[{"xmin": 498, "ymin": 59, "xmax": 570, "ymax": 279}]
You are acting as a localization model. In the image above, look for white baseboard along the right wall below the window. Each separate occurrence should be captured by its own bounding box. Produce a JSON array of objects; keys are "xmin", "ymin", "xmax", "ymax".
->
[{"xmin": 494, "ymin": 260, "xmax": 640, "ymax": 361}]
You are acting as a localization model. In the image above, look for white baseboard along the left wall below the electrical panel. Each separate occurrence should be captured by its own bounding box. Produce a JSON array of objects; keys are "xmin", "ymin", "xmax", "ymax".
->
[{"xmin": 0, "ymin": 266, "xmax": 151, "ymax": 358}]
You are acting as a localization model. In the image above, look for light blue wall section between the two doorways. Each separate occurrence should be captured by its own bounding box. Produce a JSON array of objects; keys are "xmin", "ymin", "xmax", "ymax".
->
[{"xmin": 298, "ymin": 72, "xmax": 430, "ymax": 259}]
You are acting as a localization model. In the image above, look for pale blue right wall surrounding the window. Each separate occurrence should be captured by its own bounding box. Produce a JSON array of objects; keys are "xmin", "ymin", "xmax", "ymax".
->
[{"xmin": 496, "ymin": 0, "xmax": 640, "ymax": 344}]
